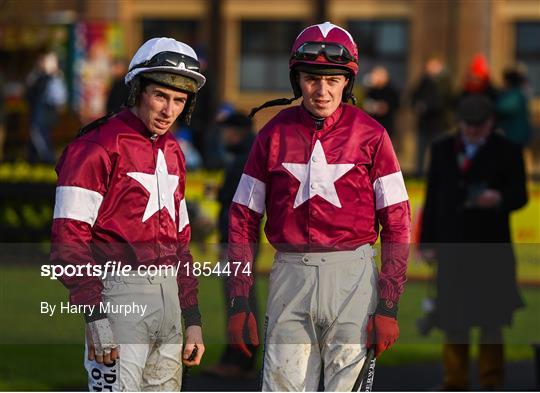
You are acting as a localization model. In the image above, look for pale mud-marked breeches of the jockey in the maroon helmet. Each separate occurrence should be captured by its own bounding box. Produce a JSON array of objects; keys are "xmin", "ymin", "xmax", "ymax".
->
[{"xmin": 262, "ymin": 245, "xmax": 378, "ymax": 391}]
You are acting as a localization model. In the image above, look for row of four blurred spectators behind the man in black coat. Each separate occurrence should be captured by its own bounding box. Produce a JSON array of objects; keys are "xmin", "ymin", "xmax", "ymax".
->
[{"xmin": 360, "ymin": 53, "xmax": 532, "ymax": 176}]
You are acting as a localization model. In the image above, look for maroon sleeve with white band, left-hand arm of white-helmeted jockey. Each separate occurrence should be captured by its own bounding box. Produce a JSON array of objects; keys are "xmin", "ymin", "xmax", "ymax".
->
[{"xmin": 50, "ymin": 141, "xmax": 111, "ymax": 305}]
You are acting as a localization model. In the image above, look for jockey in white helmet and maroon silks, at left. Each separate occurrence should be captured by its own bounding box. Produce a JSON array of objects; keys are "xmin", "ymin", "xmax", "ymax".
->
[{"xmin": 51, "ymin": 37, "xmax": 206, "ymax": 391}]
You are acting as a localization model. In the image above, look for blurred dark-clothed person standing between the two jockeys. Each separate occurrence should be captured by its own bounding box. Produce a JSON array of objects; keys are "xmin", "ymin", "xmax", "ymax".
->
[{"xmin": 207, "ymin": 112, "xmax": 258, "ymax": 378}]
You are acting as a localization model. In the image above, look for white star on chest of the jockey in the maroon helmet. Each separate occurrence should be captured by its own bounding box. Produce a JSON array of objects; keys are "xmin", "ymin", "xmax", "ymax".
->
[{"xmin": 282, "ymin": 141, "xmax": 354, "ymax": 209}]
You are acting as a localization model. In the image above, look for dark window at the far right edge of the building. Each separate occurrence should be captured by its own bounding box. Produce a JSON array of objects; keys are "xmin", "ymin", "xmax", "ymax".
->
[{"xmin": 516, "ymin": 22, "xmax": 540, "ymax": 96}]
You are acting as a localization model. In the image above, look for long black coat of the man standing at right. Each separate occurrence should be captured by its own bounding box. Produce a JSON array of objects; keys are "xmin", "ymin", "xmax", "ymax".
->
[{"xmin": 421, "ymin": 134, "xmax": 527, "ymax": 330}]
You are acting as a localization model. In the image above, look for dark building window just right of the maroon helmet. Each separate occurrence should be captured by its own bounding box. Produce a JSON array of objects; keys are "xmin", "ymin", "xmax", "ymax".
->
[{"xmin": 348, "ymin": 20, "xmax": 409, "ymax": 89}]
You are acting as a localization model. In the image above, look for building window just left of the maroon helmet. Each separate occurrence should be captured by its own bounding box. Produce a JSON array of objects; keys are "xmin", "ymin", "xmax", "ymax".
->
[{"xmin": 238, "ymin": 20, "xmax": 303, "ymax": 91}]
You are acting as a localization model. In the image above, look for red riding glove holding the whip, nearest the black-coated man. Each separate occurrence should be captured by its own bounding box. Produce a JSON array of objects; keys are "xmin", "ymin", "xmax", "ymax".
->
[{"xmin": 367, "ymin": 299, "xmax": 399, "ymax": 356}]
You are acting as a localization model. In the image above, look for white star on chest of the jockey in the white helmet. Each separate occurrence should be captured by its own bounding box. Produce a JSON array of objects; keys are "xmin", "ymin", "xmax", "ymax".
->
[{"xmin": 127, "ymin": 149, "xmax": 178, "ymax": 222}]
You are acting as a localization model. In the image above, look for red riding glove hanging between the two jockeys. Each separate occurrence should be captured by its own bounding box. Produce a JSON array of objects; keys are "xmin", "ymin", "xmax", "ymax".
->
[{"xmin": 227, "ymin": 297, "xmax": 259, "ymax": 357}]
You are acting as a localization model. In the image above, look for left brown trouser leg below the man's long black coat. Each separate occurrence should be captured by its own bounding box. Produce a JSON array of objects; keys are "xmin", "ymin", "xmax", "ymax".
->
[{"xmin": 441, "ymin": 343, "xmax": 469, "ymax": 390}]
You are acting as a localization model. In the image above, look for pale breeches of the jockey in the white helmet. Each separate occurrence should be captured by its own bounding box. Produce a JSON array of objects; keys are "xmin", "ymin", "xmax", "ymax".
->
[{"xmin": 84, "ymin": 277, "xmax": 183, "ymax": 391}]
